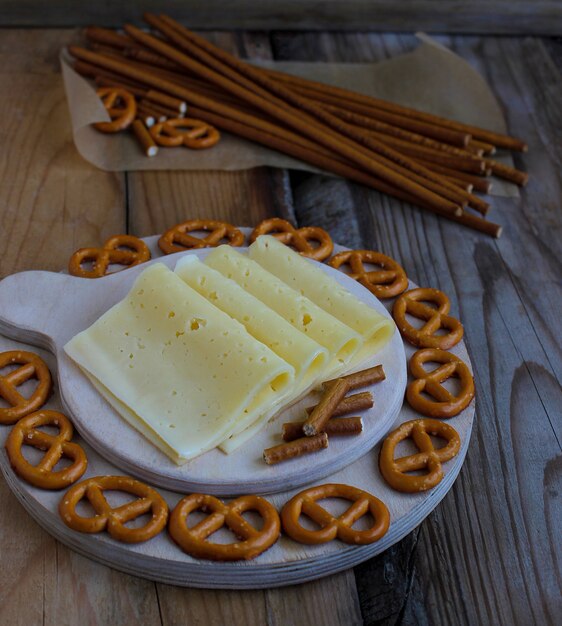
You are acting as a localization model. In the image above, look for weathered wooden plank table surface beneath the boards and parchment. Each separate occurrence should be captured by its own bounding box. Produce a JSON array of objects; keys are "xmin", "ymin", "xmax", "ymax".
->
[{"xmin": 0, "ymin": 29, "xmax": 562, "ymax": 626}]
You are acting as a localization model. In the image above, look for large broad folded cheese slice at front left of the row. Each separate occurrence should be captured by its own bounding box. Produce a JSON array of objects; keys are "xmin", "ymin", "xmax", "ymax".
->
[{"xmin": 65, "ymin": 263, "xmax": 294, "ymax": 463}]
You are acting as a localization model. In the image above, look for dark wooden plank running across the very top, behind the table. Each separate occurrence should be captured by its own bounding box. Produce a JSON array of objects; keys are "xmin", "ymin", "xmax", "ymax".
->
[{"xmin": 0, "ymin": 0, "xmax": 562, "ymax": 35}]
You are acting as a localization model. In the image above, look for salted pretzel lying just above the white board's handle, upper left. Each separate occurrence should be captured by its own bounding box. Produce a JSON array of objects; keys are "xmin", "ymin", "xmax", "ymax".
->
[{"xmin": 68, "ymin": 235, "xmax": 150, "ymax": 278}]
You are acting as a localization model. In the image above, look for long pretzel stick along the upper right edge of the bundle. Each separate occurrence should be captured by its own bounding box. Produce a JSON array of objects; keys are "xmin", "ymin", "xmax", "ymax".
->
[{"xmin": 256, "ymin": 63, "xmax": 527, "ymax": 152}]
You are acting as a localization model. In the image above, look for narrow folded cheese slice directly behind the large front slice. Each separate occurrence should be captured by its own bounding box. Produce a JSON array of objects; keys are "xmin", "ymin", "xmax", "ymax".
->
[{"xmin": 174, "ymin": 254, "xmax": 329, "ymax": 393}]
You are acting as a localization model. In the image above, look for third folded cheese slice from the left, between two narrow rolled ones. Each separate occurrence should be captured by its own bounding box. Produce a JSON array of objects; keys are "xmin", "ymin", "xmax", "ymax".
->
[{"xmin": 205, "ymin": 245, "xmax": 363, "ymax": 378}]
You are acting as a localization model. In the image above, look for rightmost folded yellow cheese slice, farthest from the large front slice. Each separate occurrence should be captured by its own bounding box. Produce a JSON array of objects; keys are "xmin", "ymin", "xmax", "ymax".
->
[{"xmin": 249, "ymin": 235, "xmax": 395, "ymax": 365}]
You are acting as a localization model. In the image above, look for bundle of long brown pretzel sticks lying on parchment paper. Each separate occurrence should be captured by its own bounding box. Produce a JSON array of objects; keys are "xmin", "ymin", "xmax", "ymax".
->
[{"xmin": 70, "ymin": 14, "xmax": 528, "ymax": 237}]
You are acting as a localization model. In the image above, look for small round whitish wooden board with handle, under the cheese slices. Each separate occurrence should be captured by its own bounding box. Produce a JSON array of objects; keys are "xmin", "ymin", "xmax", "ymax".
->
[{"xmin": 0, "ymin": 237, "xmax": 406, "ymax": 496}]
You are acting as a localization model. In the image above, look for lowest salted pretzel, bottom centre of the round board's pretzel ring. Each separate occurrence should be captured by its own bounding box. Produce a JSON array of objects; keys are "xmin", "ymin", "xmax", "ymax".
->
[{"xmin": 168, "ymin": 493, "xmax": 281, "ymax": 561}]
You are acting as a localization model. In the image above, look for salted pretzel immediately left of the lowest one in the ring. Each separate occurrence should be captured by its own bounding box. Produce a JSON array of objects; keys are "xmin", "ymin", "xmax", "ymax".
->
[{"xmin": 59, "ymin": 476, "xmax": 168, "ymax": 543}]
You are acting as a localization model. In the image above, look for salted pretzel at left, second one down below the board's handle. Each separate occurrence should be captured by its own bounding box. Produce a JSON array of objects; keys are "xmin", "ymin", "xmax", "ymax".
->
[{"xmin": 6, "ymin": 410, "xmax": 88, "ymax": 489}]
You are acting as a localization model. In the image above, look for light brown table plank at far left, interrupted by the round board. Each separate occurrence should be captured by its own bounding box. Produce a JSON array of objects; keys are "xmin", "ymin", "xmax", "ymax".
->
[{"xmin": 0, "ymin": 30, "xmax": 159, "ymax": 625}]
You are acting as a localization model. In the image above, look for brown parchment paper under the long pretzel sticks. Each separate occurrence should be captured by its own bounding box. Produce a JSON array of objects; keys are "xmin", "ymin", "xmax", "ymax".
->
[{"xmin": 61, "ymin": 35, "xmax": 518, "ymax": 196}]
